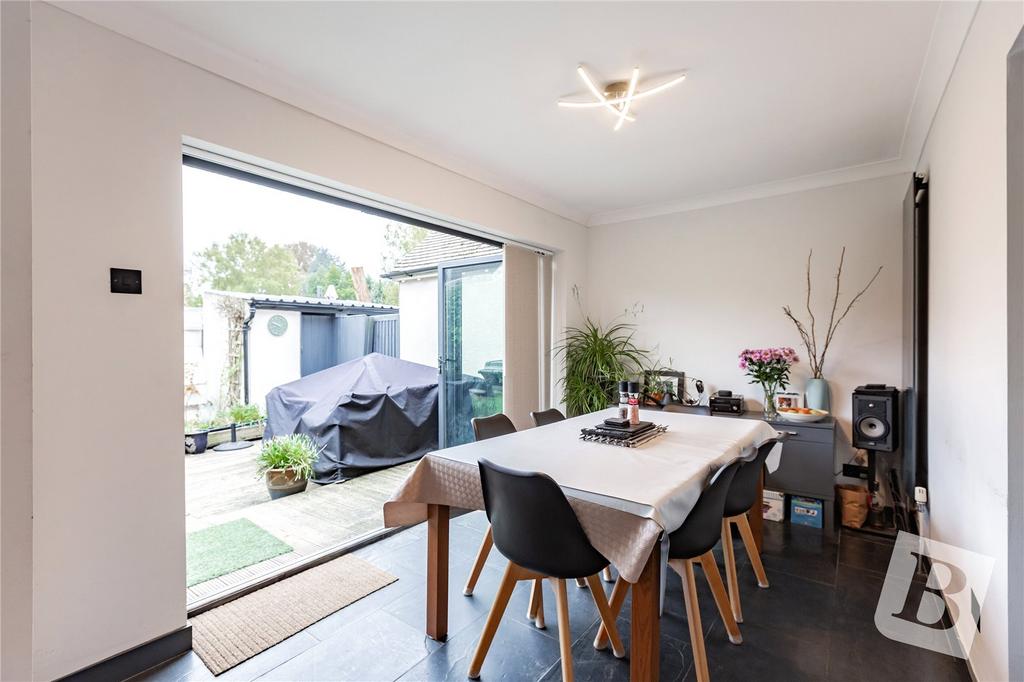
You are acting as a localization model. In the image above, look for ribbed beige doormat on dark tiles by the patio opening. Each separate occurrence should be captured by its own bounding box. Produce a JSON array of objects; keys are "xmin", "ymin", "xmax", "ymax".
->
[{"xmin": 190, "ymin": 555, "xmax": 398, "ymax": 675}]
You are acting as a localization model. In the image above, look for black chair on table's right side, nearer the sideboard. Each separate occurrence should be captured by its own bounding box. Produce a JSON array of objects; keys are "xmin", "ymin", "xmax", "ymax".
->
[{"xmin": 722, "ymin": 435, "xmax": 785, "ymax": 623}]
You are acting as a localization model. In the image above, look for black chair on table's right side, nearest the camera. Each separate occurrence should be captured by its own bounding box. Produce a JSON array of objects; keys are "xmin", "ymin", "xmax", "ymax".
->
[{"xmin": 594, "ymin": 460, "xmax": 743, "ymax": 682}]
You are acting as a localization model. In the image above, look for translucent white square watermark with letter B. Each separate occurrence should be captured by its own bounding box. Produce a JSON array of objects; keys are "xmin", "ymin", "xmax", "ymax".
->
[{"xmin": 874, "ymin": 531, "xmax": 995, "ymax": 658}]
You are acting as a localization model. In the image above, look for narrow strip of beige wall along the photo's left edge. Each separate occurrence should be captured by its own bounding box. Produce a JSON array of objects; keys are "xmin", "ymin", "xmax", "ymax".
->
[{"xmin": 0, "ymin": 2, "xmax": 33, "ymax": 680}]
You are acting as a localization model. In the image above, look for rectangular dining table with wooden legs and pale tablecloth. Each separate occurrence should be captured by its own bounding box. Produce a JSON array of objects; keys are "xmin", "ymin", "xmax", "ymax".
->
[{"xmin": 384, "ymin": 408, "xmax": 777, "ymax": 681}]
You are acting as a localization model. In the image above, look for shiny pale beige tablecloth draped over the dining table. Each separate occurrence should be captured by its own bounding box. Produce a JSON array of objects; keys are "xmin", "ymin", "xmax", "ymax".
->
[{"xmin": 384, "ymin": 409, "xmax": 776, "ymax": 582}]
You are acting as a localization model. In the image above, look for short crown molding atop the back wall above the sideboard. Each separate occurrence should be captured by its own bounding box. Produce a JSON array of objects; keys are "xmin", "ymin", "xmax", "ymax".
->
[{"xmin": 587, "ymin": 159, "xmax": 911, "ymax": 227}]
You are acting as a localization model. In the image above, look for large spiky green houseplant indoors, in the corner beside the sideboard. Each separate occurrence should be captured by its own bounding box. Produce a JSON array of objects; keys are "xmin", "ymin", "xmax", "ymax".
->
[{"xmin": 556, "ymin": 317, "xmax": 650, "ymax": 417}]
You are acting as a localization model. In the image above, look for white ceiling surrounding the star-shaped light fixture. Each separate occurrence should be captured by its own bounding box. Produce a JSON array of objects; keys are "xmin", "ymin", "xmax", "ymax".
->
[{"xmin": 60, "ymin": 2, "xmax": 969, "ymax": 224}]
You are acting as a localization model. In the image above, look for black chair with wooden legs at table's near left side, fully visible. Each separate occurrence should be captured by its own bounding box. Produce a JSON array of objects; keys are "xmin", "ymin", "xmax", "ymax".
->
[{"xmin": 468, "ymin": 460, "xmax": 626, "ymax": 681}]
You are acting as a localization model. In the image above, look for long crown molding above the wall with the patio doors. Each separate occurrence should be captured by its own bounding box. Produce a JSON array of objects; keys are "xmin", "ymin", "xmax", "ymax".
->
[{"xmin": 45, "ymin": 0, "xmax": 587, "ymax": 225}]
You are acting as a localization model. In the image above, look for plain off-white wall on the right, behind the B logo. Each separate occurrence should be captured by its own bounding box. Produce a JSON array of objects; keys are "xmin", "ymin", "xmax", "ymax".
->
[{"xmin": 920, "ymin": 2, "xmax": 1024, "ymax": 680}]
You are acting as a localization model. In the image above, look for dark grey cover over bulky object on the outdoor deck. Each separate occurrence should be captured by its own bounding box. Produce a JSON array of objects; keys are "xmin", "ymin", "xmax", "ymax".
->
[{"xmin": 264, "ymin": 353, "xmax": 437, "ymax": 483}]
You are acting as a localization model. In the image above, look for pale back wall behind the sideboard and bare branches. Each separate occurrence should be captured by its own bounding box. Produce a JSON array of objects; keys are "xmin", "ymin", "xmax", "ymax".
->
[{"xmin": 587, "ymin": 174, "xmax": 910, "ymax": 469}]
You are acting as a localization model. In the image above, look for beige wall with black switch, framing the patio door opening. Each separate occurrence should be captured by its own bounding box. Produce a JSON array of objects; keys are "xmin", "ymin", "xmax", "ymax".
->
[{"xmin": 24, "ymin": 3, "xmax": 586, "ymax": 679}]
